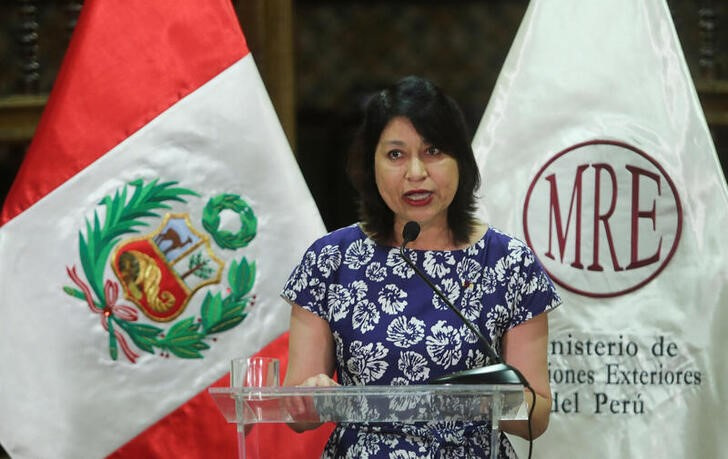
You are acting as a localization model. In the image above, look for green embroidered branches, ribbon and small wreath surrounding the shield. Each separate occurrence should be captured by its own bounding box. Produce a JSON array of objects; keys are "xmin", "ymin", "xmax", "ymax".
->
[{"xmin": 63, "ymin": 180, "xmax": 256, "ymax": 363}]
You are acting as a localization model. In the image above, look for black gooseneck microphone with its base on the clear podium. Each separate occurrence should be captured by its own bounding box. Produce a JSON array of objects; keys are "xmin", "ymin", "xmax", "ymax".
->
[{"xmin": 399, "ymin": 221, "xmax": 528, "ymax": 386}]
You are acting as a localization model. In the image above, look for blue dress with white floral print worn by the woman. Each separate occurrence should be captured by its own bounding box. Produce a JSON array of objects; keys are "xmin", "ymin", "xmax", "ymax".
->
[{"xmin": 282, "ymin": 224, "xmax": 561, "ymax": 459}]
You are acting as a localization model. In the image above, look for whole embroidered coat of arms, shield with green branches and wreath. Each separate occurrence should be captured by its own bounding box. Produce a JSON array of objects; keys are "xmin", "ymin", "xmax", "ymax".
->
[{"xmin": 63, "ymin": 180, "xmax": 257, "ymax": 363}]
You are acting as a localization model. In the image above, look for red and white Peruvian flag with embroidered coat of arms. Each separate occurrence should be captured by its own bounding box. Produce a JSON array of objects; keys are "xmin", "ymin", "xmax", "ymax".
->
[{"xmin": 0, "ymin": 0, "xmax": 327, "ymax": 458}]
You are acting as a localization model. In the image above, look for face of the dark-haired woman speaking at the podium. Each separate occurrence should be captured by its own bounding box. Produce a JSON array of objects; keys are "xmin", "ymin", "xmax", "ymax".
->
[{"xmin": 374, "ymin": 116, "xmax": 459, "ymax": 234}]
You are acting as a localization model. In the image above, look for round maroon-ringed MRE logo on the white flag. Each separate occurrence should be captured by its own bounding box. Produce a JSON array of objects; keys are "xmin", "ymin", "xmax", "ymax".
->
[{"xmin": 523, "ymin": 140, "xmax": 682, "ymax": 297}]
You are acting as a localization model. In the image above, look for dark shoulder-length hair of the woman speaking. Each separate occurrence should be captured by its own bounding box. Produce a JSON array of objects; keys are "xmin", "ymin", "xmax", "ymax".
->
[{"xmin": 347, "ymin": 76, "xmax": 480, "ymax": 248}]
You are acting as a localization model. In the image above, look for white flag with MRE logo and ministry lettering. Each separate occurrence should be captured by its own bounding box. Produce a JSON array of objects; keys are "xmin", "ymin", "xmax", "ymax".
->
[{"xmin": 473, "ymin": 0, "xmax": 728, "ymax": 458}]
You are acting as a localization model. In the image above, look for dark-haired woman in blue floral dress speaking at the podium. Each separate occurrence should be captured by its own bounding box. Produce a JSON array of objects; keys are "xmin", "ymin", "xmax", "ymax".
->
[{"xmin": 283, "ymin": 77, "xmax": 561, "ymax": 458}]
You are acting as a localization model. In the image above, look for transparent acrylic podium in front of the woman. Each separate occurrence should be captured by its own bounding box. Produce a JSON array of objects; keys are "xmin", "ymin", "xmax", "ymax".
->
[{"xmin": 209, "ymin": 384, "xmax": 526, "ymax": 458}]
